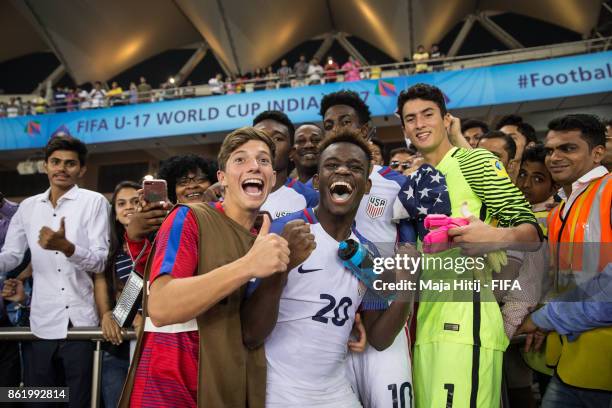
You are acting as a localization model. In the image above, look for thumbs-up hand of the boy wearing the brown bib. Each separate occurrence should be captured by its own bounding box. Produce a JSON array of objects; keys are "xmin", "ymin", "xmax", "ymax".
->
[{"xmin": 245, "ymin": 216, "xmax": 289, "ymax": 278}]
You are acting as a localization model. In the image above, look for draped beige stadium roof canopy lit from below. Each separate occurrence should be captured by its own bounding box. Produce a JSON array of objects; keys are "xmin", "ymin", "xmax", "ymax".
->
[{"xmin": 0, "ymin": 0, "xmax": 602, "ymax": 84}]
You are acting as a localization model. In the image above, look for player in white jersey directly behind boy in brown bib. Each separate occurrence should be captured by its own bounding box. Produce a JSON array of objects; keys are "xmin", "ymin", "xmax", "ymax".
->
[{"xmin": 253, "ymin": 111, "xmax": 318, "ymax": 219}]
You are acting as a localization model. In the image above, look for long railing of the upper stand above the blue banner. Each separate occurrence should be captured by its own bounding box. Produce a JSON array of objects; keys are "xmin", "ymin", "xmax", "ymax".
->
[{"xmin": 0, "ymin": 37, "xmax": 612, "ymax": 115}]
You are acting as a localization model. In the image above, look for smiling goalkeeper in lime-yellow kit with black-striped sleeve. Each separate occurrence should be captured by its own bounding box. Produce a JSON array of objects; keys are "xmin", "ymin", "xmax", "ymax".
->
[{"xmin": 398, "ymin": 84, "xmax": 541, "ymax": 408}]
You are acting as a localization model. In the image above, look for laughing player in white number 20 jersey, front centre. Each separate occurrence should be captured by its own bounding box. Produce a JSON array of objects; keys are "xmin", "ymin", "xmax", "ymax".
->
[{"xmin": 255, "ymin": 129, "xmax": 416, "ymax": 408}]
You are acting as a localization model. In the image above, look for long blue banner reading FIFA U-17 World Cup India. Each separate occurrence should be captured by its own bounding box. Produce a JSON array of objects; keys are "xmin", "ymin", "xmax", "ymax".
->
[{"xmin": 0, "ymin": 51, "xmax": 612, "ymax": 150}]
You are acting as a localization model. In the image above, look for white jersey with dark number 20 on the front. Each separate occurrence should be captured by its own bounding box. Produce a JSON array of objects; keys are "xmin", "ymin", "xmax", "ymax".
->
[{"xmin": 265, "ymin": 209, "xmax": 365, "ymax": 408}]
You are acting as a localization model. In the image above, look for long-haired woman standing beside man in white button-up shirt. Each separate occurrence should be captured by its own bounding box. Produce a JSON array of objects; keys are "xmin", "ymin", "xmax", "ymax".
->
[{"xmin": 94, "ymin": 181, "xmax": 143, "ymax": 408}]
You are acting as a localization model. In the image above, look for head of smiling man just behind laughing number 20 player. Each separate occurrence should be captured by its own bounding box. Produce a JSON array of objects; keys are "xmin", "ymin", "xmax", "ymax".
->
[{"xmin": 290, "ymin": 123, "xmax": 323, "ymax": 184}]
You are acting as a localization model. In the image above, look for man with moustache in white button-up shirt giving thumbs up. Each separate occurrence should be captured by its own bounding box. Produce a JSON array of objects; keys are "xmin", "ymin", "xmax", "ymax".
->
[{"xmin": 0, "ymin": 136, "xmax": 110, "ymax": 407}]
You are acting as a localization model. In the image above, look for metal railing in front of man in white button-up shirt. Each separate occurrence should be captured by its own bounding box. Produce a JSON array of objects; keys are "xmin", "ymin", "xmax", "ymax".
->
[{"xmin": 0, "ymin": 327, "xmax": 136, "ymax": 408}]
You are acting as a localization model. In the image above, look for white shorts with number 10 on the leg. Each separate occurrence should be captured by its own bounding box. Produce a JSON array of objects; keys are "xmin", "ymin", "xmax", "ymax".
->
[{"xmin": 347, "ymin": 328, "xmax": 414, "ymax": 408}]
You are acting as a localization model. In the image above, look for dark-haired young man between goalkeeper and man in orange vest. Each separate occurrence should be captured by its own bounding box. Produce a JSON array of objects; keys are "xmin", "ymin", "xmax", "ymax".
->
[{"xmin": 516, "ymin": 144, "xmax": 558, "ymax": 236}]
